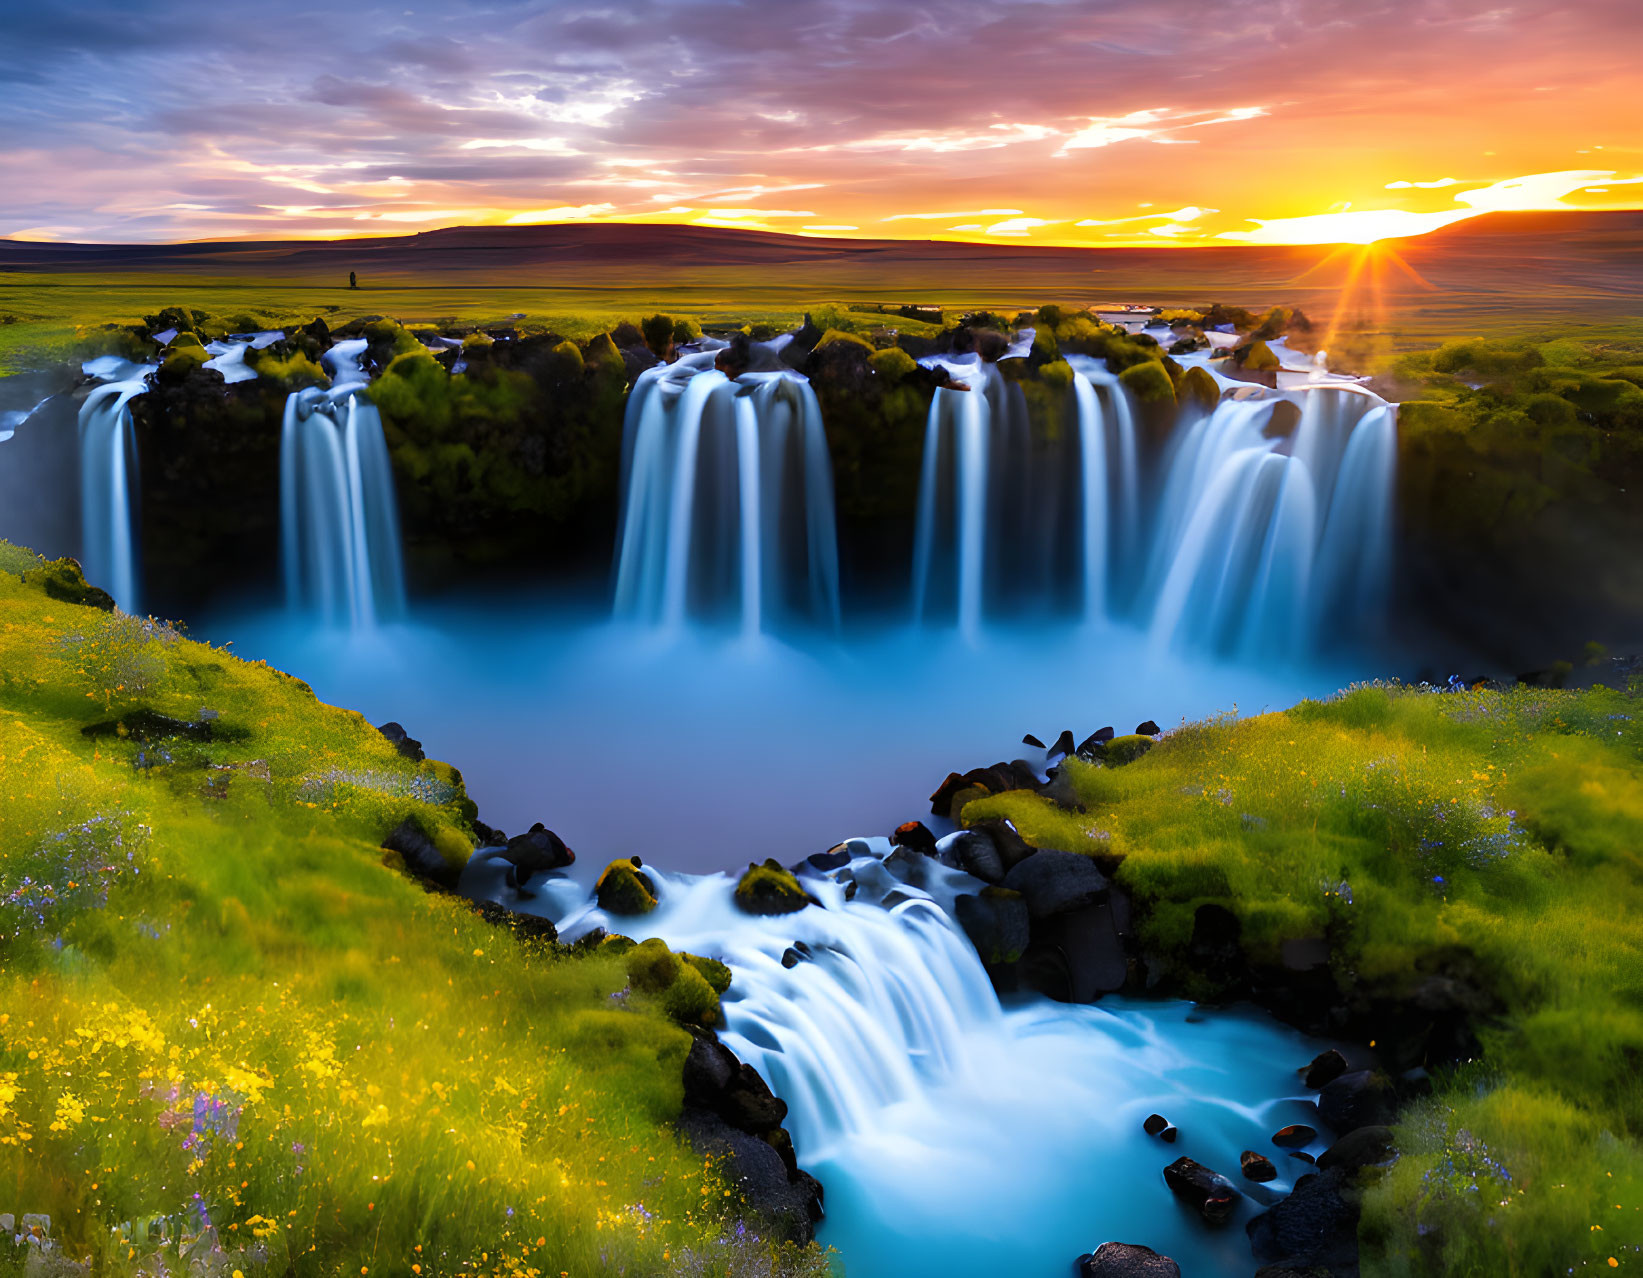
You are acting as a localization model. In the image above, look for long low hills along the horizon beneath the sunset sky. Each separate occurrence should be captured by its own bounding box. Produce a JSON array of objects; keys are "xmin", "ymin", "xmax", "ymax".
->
[{"xmin": 0, "ymin": 212, "xmax": 1643, "ymax": 338}]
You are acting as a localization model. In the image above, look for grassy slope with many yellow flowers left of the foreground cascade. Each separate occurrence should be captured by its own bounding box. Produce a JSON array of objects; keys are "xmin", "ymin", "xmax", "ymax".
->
[{"xmin": 0, "ymin": 560, "xmax": 828, "ymax": 1278}]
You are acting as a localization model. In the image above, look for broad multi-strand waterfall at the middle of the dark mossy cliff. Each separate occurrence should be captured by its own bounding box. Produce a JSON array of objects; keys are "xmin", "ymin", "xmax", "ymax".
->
[{"xmin": 614, "ymin": 350, "xmax": 840, "ymax": 634}]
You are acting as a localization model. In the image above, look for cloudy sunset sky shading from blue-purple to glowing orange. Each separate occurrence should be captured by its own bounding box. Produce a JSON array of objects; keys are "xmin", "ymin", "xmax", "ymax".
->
[{"xmin": 0, "ymin": 0, "xmax": 1643, "ymax": 246}]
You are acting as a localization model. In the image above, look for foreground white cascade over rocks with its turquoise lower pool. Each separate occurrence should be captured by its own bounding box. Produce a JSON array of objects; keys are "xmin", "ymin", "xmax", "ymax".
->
[{"xmin": 463, "ymin": 839, "xmax": 1319, "ymax": 1278}]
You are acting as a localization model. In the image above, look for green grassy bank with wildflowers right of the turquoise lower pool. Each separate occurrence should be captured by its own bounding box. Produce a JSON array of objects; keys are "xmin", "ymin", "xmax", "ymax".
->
[{"xmin": 963, "ymin": 687, "xmax": 1643, "ymax": 1278}]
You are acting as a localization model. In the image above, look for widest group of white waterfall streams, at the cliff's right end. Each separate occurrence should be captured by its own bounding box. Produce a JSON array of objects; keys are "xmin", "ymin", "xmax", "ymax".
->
[{"xmin": 912, "ymin": 353, "xmax": 1397, "ymax": 660}]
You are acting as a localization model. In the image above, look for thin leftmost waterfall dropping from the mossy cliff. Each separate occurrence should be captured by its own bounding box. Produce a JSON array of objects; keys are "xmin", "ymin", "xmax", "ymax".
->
[{"xmin": 79, "ymin": 356, "xmax": 154, "ymax": 613}]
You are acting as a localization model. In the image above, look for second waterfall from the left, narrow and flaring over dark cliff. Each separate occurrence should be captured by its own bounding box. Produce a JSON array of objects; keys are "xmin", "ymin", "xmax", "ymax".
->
[{"xmin": 279, "ymin": 338, "xmax": 406, "ymax": 628}]
